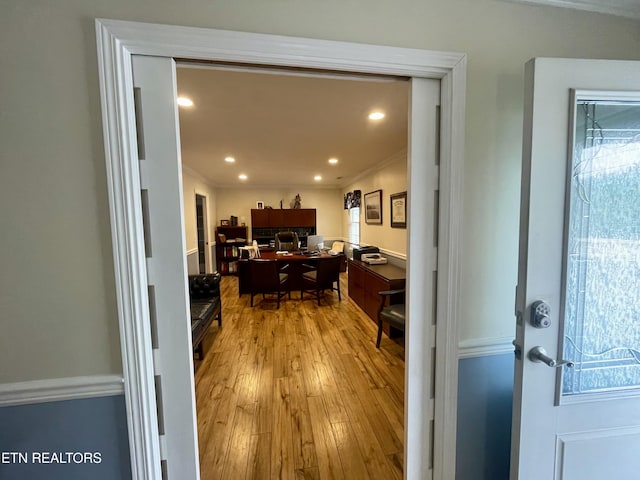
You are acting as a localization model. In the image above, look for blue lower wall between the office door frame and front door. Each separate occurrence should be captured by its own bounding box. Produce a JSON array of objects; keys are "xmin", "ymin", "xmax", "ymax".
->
[{"xmin": 456, "ymin": 353, "xmax": 513, "ymax": 480}]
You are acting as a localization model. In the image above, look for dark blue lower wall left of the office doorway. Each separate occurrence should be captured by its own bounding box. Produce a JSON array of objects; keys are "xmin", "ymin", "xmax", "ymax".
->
[{"xmin": 0, "ymin": 395, "xmax": 131, "ymax": 480}]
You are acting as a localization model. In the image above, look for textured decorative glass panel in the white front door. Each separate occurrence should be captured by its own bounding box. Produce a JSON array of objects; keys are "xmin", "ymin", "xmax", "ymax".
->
[{"xmin": 562, "ymin": 97, "xmax": 640, "ymax": 396}]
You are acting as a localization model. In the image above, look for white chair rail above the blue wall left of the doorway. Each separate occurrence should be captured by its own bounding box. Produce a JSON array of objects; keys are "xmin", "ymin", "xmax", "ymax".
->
[{"xmin": 0, "ymin": 375, "xmax": 124, "ymax": 407}]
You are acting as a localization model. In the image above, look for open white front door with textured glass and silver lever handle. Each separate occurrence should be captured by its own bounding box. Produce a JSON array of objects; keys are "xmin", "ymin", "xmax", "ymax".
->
[{"xmin": 511, "ymin": 59, "xmax": 640, "ymax": 480}]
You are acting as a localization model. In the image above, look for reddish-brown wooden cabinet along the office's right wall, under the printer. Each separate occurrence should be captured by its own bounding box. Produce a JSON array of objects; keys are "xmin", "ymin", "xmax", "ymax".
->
[{"xmin": 348, "ymin": 259, "xmax": 406, "ymax": 335}]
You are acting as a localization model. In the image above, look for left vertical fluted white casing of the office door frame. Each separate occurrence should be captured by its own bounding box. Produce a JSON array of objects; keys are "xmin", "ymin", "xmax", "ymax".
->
[{"xmin": 96, "ymin": 21, "xmax": 162, "ymax": 480}]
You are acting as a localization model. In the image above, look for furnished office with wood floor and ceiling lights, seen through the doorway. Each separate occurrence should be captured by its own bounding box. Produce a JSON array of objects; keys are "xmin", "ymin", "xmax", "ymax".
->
[{"xmin": 177, "ymin": 64, "xmax": 409, "ymax": 479}]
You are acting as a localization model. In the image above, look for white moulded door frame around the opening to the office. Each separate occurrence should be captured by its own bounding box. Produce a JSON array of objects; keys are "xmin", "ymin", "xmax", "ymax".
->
[{"xmin": 96, "ymin": 19, "xmax": 466, "ymax": 480}]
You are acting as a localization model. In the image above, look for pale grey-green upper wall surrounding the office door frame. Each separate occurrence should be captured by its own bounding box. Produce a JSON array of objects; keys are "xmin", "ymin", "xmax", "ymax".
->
[{"xmin": 0, "ymin": 0, "xmax": 640, "ymax": 382}]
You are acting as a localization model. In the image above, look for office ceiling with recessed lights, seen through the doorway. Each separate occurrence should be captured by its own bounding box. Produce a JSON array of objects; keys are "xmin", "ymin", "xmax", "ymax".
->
[{"xmin": 177, "ymin": 64, "xmax": 409, "ymax": 188}]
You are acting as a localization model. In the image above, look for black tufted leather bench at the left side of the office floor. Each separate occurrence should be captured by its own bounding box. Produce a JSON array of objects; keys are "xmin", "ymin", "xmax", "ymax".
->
[{"xmin": 189, "ymin": 272, "xmax": 222, "ymax": 359}]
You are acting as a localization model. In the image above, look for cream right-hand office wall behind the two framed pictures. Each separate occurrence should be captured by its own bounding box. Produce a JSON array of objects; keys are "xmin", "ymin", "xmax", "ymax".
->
[{"xmin": 342, "ymin": 151, "xmax": 407, "ymax": 258}]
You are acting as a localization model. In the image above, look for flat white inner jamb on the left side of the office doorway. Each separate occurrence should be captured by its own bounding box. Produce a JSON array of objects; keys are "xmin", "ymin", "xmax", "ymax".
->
[{"xmin": 132, "ymin": 55, "xmax": 199, "ymax": 479}]
